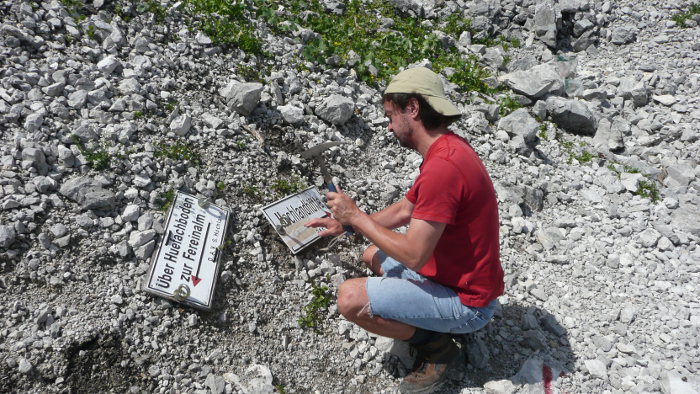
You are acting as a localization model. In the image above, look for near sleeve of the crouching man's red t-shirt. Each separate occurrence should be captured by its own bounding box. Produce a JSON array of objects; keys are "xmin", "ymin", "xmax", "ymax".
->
[{"xmin": 406, "ymin": 158, "xmax": 465, "ymax": 224}]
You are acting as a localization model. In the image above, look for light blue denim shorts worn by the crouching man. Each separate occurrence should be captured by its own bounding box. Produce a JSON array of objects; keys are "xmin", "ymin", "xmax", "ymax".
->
[{"xmin": 367, "ymin": 250, "xmax": 498, "ymax": 334}]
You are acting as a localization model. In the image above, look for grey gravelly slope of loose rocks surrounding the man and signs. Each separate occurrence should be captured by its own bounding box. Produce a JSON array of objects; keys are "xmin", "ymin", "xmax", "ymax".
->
[{"xmin": 0, "ymin": 0, "xmax": 700, "ymax": 393}]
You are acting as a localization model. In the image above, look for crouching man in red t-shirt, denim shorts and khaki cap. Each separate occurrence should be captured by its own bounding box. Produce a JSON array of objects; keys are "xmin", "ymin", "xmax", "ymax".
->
[{"xmin": 306, "ymin": 67, "xmax": 503, "ymax": 393}]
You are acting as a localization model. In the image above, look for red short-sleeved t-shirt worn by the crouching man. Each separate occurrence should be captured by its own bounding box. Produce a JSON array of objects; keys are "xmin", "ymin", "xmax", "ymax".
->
[{"xmin": 406, "ymin": 133, "xmax": 503, "ymax": 307}]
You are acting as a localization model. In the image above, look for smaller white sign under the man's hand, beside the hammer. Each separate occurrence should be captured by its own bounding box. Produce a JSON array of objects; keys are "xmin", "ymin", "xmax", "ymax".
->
[{"xmin": 261, "ymin": 186, "xmax": 331, "ymax": 253}]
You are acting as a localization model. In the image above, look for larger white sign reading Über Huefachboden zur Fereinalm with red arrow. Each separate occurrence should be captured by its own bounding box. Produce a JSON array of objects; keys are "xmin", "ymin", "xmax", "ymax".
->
[{"xmin": 145, "ymin": 192, "xmax": 228, "ymax": 309}]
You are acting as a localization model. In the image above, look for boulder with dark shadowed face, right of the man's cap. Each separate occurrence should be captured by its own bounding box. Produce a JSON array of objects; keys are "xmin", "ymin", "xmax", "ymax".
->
[{"xmin": 547, "ymin": 97, "xmax": 598, "ymax": 136}]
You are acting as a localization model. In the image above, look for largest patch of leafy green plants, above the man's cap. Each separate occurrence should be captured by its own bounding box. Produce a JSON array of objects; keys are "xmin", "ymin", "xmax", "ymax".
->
[{"xmin": 288, "ymin": 0, "xmax": 492, "ymax": 92}]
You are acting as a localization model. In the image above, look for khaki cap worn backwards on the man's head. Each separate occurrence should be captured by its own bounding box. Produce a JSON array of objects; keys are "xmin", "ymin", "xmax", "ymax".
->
[{"xmin": 384, "ymin": 67, "xmax": 462, "ymax": 116}]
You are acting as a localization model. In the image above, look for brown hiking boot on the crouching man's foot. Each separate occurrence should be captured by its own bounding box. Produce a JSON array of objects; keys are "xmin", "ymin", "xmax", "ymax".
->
[{"xmin": 399, "ymin": 334, "xmax": 460, "ymax": 393}]
